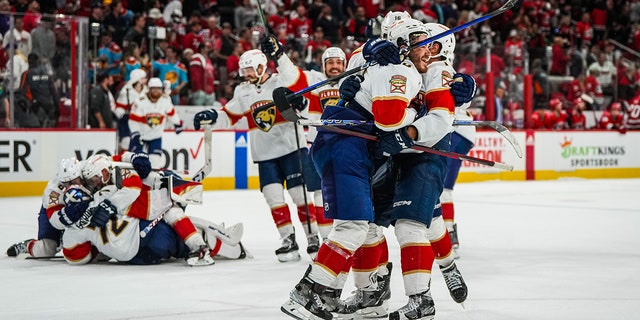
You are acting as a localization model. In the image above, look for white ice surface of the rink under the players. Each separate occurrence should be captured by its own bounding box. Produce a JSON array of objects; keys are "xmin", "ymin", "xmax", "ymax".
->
[{"xmin": 0, "ymin": 179, "xmax": 640, "ymax": 320}]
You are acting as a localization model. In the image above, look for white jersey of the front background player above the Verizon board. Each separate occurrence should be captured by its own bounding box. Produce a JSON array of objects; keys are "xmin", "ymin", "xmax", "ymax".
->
[{"xmin": 129, "ymin": 94, "xmax": 182, "ymax": 141}]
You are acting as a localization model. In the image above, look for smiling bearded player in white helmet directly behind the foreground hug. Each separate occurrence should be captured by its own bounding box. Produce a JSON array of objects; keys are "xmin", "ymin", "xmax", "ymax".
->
[{"xmin": 304, "ymin": 47, "xmax": 347, "ymax": 239}]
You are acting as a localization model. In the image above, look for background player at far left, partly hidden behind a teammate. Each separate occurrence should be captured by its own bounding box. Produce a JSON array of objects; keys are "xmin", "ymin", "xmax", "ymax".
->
[{"xmin": 113, "ymin": 69, "xmax": 147, "ymax": 150}]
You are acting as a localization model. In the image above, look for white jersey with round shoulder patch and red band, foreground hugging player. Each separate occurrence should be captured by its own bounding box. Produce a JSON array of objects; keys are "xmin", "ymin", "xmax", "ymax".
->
[{"xmin": 354, "ymin": 60, "xmax": 422, "ymax": 131}]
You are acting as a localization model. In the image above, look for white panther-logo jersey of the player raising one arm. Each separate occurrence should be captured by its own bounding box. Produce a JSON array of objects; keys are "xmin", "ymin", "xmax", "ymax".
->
[{"xmin": 223, "ymin": 54, "xmax": 308, "ymax": 162}]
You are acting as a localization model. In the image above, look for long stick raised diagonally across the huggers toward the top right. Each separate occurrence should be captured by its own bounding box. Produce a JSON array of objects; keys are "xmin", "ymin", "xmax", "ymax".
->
[{"xmin": 254, "ymin": 0, "xmax": 518, "ymax": 115}]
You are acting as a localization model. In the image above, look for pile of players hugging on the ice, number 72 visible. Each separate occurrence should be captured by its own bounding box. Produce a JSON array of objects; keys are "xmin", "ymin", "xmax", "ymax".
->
[{"xmin": 7, "ymin": 152, "xmax": 247, "ymax": 265}]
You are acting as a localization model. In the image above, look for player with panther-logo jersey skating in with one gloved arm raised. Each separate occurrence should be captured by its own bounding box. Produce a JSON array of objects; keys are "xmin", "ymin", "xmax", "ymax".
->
[{"xmin": 194, "ymin": 43, "xmax": 319, "ymax": 262}]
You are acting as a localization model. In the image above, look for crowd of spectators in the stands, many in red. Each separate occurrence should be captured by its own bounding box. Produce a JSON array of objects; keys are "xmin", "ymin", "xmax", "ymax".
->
[{"xmin": 0, "ymin": 0, "xmax": 640, "ymax": 129}]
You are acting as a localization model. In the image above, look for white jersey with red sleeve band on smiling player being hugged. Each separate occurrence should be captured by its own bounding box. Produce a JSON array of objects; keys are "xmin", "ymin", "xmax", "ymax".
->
[{"xmin": 412, "ymin": 61, "xmax": 456, "ymax": 147}]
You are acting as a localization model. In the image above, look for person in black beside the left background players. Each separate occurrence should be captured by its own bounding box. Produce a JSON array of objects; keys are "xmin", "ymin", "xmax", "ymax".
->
[{"xmin": 89, "ymin": 73, "xmax": 115, "ymax": 129}]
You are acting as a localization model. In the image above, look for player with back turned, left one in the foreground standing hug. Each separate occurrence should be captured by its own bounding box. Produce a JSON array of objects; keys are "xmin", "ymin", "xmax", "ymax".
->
[{"xmin": 282, "ymin": 21, "xmax": 426, "ymax": 319}]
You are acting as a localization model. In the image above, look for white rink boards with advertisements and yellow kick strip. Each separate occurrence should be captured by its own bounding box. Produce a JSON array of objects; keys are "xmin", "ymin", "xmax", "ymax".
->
[{"xmin": 0, "ymin": 130, "xmax": 640, "ymax": 196}]
